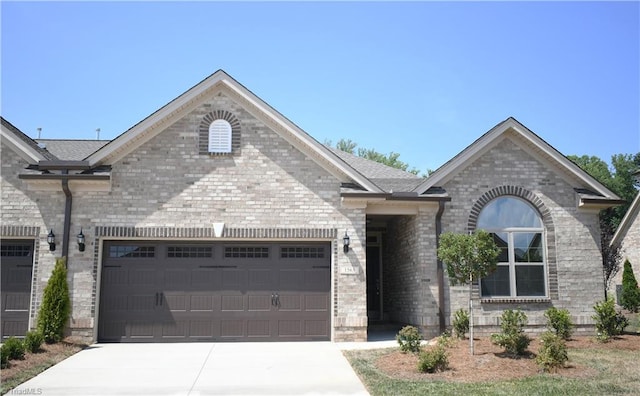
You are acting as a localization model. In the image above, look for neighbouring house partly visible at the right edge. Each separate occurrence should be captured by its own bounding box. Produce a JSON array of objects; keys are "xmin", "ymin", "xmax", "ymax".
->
[{"xmin": 611, "ymin": 181, "xmax": 640, "ymax": 301}]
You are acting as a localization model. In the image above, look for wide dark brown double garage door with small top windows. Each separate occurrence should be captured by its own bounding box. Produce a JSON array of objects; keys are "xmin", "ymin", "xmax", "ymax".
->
[{"xmin": 98, "ymin": 241, "xmax": 331, "ymax": 342}]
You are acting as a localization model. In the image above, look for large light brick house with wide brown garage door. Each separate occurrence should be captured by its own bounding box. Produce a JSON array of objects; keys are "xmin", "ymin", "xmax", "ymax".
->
[{"xmin": 0, "ymin": 70, "xmax": 620, "ymax": 342}]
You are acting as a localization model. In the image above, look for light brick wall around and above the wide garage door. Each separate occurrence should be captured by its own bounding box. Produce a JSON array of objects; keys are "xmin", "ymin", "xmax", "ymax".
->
[{"xmin": 2, "ymin": 94, "xmax": 367, "ymax": 341}]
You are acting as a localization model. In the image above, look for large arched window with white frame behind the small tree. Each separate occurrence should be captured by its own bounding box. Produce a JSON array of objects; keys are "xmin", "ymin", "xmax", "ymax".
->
[{"xmin": 476, "ymin": 196, "xmax": 547, "ymax": 298}]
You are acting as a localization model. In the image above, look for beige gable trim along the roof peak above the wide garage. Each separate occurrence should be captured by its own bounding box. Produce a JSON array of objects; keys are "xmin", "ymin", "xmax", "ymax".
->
[{"xmin": 87, "ymin": 70, "xmax": 381, "ymax": 192}]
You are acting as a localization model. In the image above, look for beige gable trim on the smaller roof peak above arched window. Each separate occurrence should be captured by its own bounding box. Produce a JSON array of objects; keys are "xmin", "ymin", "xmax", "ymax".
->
[{"xmin": 414, "ymin": 117, "xmax": 620, "ymax": 201}]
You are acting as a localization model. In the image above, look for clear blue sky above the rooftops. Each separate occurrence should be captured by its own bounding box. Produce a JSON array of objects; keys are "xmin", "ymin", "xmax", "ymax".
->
[{"xmin": 0, "ymin": 1, "xmax": 640, "ymax": 171}]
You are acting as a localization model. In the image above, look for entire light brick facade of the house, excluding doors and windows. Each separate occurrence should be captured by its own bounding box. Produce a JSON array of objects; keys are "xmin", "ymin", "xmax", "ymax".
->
[{"xmin": 1, "ymin": 73, "xmax": 620, "ymax": 341}]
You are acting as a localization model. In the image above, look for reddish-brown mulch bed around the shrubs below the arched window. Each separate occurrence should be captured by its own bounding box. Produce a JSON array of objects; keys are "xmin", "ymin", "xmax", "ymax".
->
[{"xmin": 376, "ymin": 335, "xmax": 640, "ymax": 382}]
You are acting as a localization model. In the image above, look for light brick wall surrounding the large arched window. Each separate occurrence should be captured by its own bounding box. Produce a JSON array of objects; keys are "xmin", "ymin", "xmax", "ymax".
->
[{"xmin": 442, "ymin": 138, "xmax": 604, "ymax": 329}]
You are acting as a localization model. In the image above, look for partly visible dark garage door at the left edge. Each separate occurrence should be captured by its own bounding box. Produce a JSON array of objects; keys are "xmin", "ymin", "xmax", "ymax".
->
[{"xmin": 0, "ymin": 239, "xmax": 33, "ymax": 338}]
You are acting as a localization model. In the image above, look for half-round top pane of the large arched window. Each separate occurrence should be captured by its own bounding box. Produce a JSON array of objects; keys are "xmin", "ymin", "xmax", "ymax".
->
[{"xmin": 477, "ymin": 197, "xmax": 542, "ymax": 230}]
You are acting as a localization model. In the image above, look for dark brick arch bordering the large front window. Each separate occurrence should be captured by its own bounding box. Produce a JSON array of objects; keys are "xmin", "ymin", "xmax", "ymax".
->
[{"xmin": 467, "ymin": 186, "xmax": 558, "ymax": 300}]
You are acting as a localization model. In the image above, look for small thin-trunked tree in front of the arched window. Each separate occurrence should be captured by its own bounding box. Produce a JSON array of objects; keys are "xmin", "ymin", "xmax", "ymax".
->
[{"xmin": 438, "ymin": 230, "xmax": 500, "ymax": 355}]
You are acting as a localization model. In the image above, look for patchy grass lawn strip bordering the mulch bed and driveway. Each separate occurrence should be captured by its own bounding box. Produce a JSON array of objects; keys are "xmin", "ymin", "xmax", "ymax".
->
[{"xmin": 345, "ymin": 342, "xmax": 640, "ymax": 396}]
